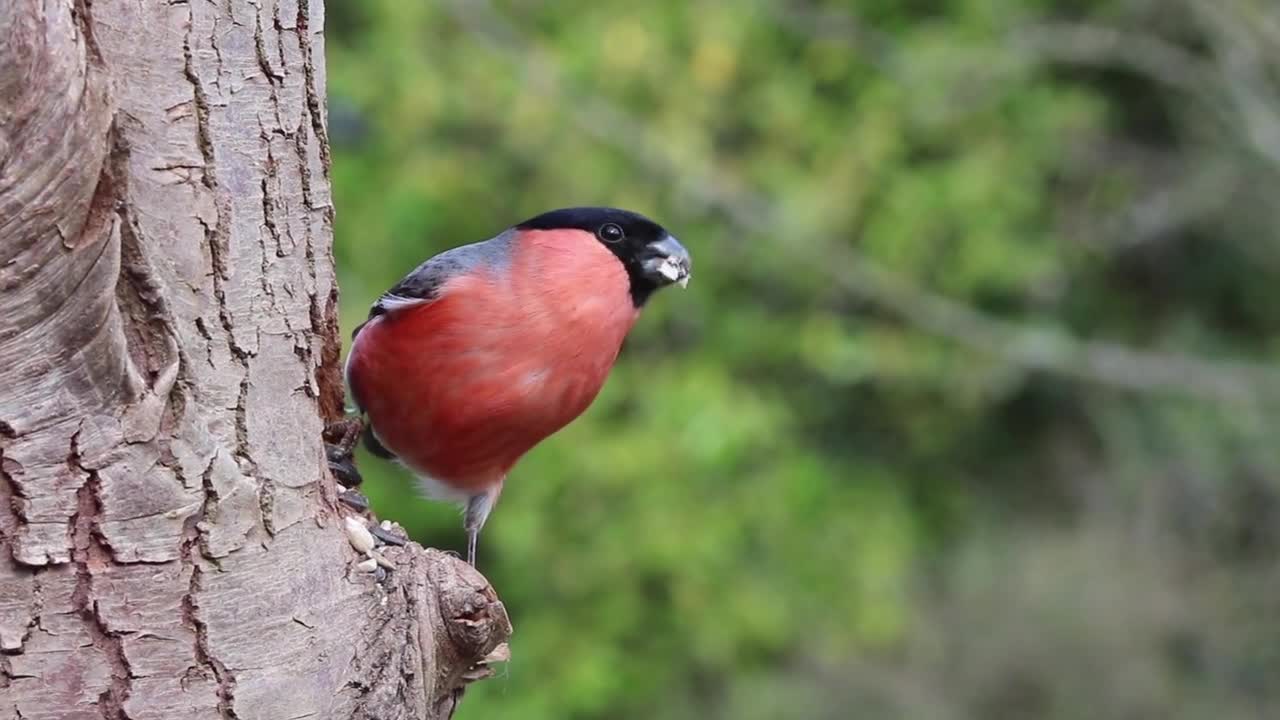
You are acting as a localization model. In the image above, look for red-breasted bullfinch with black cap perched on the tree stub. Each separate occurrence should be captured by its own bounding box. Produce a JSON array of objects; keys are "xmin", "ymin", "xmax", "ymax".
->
[{"xmin": 344, "ymin": 208, "xmax": 692, "ymax": 566}]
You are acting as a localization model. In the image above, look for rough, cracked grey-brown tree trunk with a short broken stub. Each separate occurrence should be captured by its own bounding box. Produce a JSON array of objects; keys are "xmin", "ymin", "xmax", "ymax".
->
[{"xmin": 0, "ymin": 0, "xmax": 509, "ymax": 720}]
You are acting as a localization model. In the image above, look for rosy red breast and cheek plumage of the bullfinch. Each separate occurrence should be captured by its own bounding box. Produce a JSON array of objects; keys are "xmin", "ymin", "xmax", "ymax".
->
[{"xmin": 347, "ymin": 229, "xmax": 639, "ymax": 495}]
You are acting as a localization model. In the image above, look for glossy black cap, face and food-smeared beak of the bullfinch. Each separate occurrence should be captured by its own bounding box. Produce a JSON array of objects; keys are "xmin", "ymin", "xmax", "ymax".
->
[{"xmin": 516, "ymin": 208, "xmax": 692, "ymax": 307}]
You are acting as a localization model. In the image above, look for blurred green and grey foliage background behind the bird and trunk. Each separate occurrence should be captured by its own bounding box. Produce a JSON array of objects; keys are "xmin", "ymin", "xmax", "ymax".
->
[{"xmin": 326, "ymin": 0, "xmax": 1280, "ymax": 720}]
